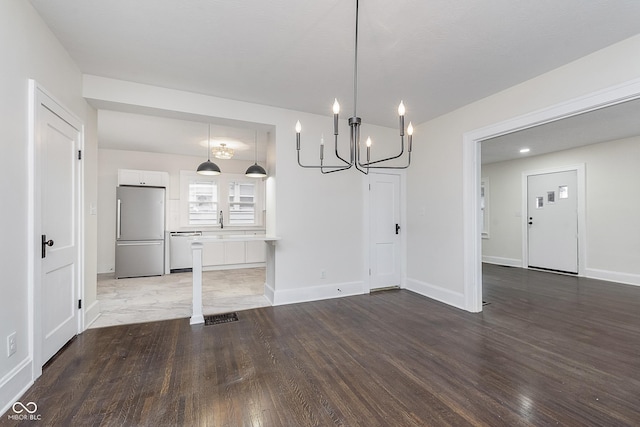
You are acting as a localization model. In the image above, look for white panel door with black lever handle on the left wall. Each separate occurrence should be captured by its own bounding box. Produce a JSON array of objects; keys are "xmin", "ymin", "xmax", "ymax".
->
[{"xmin": 35, "ymin": 93, "xmax": 80, "ymax": 364}]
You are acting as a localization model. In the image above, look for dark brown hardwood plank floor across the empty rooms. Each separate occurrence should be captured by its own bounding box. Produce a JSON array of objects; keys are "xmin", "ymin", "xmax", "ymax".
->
[{"xmin": 0, "ymin": 265, "xmax": 640, "ymax": 427}]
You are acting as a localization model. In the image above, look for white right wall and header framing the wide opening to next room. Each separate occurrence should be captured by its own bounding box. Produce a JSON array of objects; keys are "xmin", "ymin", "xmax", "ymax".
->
[{"xmin": 407, "ymin": 36, "xmax": 640, "ymax": 307}]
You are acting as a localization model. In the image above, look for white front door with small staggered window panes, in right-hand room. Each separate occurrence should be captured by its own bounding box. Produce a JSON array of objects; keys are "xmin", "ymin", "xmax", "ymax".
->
[{"xmin": 527, "ymin": 170, "xmax": 578, "ymax": 274}]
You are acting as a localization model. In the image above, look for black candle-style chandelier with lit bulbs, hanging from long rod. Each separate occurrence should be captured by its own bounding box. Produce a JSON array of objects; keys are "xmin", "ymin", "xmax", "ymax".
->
[{"xmin": 295, "ymin": 0, "xmax": 413, "ymax": 175}]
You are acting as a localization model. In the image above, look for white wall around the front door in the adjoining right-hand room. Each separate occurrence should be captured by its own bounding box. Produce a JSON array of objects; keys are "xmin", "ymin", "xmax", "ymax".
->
[{"xmin": 482, "ymin": 137, "xmax": 640, "ymax": 285}]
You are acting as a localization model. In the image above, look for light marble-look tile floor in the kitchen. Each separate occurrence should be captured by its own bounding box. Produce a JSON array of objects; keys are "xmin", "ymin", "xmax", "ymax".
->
[{"xmin": 89, "ymin": 268, "xmax": 270, "ymax": 328}]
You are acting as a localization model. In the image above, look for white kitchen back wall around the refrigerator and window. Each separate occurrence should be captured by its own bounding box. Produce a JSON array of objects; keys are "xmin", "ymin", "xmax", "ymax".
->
[{"xmin": 97, "ymin": 149, "xmax": 253, "ymax": 273}]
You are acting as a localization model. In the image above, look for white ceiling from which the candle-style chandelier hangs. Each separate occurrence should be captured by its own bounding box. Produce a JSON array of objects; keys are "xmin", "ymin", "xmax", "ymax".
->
[{"xmin": 31, "ymin": 0, "xmax": 640, "ymax": 160}]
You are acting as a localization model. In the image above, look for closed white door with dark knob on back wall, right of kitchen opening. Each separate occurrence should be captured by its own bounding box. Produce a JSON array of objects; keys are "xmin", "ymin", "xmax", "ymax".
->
[{"xmin": 369, "ymin": 173, "xmax": 402, "ymax": 289}]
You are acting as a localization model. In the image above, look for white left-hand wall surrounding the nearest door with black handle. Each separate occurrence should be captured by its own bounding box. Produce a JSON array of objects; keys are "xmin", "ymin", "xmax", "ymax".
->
[{"xmin": 0, "ymin": 0, "xmax": 95, "ymax": 412}]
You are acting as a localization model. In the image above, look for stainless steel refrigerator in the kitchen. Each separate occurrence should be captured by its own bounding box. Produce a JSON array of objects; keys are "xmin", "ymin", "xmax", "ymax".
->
[{"xmin": 116, "ymin": 185, "xmax": 165, "ymax": 279}]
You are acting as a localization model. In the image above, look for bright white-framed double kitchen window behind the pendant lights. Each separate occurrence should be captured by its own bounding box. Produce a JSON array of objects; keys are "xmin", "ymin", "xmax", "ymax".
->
[{"xmin": 180, "ymin": 171, "xmax": 264, "ymax": 227}]
